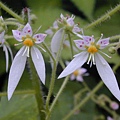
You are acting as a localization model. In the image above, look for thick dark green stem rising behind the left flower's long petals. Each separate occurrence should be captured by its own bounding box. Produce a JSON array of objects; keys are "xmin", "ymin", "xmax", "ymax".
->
[{"xmin": 29, "ymin": 58, "xmax": 45, "ymax": 120}]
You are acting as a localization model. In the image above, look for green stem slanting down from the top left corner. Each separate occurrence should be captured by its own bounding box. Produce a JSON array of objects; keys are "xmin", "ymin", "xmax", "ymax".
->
[{"xmin": 0, "ymin": 2, "xmax": 24, "ymax": 23}]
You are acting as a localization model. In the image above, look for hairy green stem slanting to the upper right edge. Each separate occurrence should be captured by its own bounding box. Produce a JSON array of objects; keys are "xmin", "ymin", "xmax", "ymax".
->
[{"xmin": 84, "ymin": 4, "xmax": 120, "ymax": 29}]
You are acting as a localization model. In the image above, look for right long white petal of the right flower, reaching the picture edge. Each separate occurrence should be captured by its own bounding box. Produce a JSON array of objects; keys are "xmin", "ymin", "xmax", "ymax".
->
[{"xmin": 95, "ymin": 53, "xmax": 120, "ymax": 101}]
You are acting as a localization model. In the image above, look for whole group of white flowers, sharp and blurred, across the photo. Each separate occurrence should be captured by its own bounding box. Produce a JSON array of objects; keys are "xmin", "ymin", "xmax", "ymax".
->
[{"xmin": 0, "ymin": 14, "xmax": 120, "ymax": 106}]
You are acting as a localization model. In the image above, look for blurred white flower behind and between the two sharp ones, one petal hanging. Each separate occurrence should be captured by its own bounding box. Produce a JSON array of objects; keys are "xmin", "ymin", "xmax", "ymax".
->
[{"xmin": 51, "ymin": 14, "xmax": 81, "ymax": 53}]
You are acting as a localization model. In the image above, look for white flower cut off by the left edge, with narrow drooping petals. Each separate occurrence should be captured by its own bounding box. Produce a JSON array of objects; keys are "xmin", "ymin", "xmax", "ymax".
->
[{"xmin": 0, "ymin": 31, "xmax": 13, "ymax": 72}]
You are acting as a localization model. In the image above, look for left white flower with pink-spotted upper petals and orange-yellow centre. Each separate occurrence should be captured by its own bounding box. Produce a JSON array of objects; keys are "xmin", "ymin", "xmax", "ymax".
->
[{"xmin": 8, "ymin": 23, "xmax": 46, "ymax": 99}]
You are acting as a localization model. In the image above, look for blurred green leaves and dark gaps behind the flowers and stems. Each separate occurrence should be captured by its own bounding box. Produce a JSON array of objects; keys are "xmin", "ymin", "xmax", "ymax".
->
[{"xmin": 0, "ymin": 0, "xmax": 120, "ymax": 120}]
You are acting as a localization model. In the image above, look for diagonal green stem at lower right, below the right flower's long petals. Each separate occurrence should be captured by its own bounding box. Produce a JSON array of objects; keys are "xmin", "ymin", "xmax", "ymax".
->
[{"xmin": 63, "ymin": 81, "xmax": 103, "ymax": 120}]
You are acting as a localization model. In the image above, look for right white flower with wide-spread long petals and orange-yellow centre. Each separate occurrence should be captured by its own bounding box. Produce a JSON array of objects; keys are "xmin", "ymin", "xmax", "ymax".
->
[{"xmin": 58, "ymin": 36, "xmax": 120, "ymax": 101}]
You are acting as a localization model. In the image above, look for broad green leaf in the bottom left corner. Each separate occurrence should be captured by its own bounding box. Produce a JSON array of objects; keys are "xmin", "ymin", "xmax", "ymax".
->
[{"xmin": 0, "ymin": 95, "xmax": 38, "ymax": 120}]
